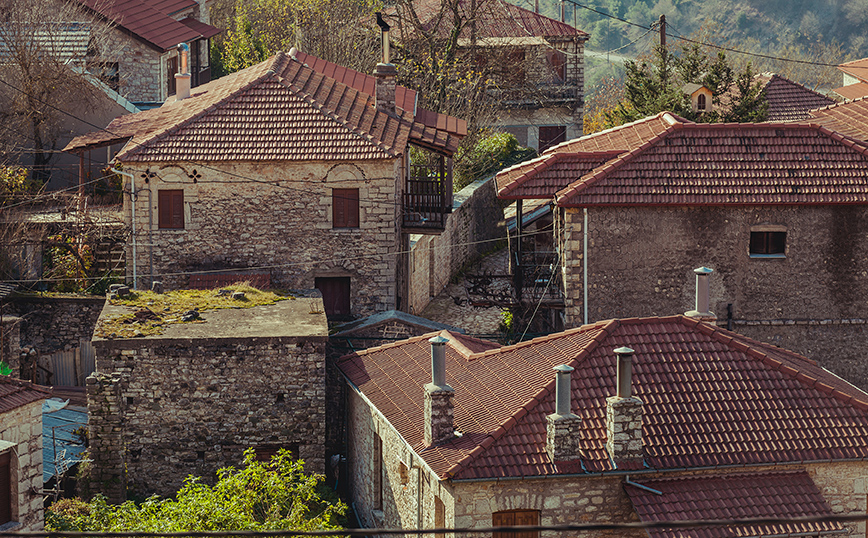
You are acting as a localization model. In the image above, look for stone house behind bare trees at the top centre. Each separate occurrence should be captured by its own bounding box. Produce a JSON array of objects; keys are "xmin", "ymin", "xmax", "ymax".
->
[{"xmin": 396, "ymin": 0, "xmax": 590, "ymax": 152}]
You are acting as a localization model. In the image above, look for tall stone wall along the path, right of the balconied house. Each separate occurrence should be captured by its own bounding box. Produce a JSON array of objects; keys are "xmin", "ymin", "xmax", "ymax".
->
[{"xmin": 410, "ymin": 174, "xmax": 506, "ymax": 314}]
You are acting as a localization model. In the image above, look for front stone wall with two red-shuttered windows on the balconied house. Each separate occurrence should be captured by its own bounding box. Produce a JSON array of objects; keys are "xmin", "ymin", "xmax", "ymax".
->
[{"xmin": 124, "ymin": 160, "xmax": 401, "ymax": 316}]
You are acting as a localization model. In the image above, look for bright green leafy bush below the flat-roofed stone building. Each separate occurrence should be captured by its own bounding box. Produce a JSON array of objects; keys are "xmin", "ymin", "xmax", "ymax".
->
[{"xmin": 45, "ymin": 449, "xmax": 346, "ymax": 533}]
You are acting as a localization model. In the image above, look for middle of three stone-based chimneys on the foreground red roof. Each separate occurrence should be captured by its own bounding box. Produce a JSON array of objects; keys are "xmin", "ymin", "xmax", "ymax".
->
[{"xmin": 546, "ymin": 364, "xmax": 582, "ymax": 463}]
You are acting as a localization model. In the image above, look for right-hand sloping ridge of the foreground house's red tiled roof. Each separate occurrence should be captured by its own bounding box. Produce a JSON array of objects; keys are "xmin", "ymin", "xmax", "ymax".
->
[{"xmin": 675, "ymin": 315, "xmax": 868, "ymax": 411}]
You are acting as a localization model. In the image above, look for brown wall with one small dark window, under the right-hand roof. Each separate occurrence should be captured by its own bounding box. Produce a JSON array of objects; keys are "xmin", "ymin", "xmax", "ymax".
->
[{"xmin": 557, "ymin": 206, "xmax": 868, "ymax": 388}]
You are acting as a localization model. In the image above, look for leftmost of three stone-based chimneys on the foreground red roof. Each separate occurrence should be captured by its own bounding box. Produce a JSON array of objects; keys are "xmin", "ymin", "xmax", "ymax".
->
[{"xmin": 425, "ymin": 335, "xmax": 455, "ymax": 446}]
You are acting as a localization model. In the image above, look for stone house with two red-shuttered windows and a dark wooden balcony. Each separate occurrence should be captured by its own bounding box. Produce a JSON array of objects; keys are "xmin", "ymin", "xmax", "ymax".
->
[{"xmin": 67, "ymin": 50, "xmax": 467, "ymax": 318}]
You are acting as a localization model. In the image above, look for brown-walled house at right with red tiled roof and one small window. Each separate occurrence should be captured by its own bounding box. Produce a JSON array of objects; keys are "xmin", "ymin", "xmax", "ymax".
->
[{"xmin": 498, "ymin": 113, "xmax": 868, "ymax": 386}]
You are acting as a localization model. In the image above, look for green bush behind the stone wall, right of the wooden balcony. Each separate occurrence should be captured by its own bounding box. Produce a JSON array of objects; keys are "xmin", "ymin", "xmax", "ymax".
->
[{"xmin": 455, "ymin": 132, "xmax": 536, "ymax": 191}]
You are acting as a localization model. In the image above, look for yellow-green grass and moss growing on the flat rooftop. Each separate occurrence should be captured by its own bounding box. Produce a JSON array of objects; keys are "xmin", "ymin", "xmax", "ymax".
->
[{"xmin": 95, "ymin": 283, "xmax": 295, "ymax": 338}]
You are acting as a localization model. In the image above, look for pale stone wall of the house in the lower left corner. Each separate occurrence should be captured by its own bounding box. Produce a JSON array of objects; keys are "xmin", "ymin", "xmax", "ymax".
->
[{"xmin": 0, "ymin": 400, "xmax": 43, "ymax": 531}]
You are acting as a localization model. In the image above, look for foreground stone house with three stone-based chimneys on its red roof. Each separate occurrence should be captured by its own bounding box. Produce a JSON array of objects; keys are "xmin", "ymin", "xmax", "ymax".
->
[{"xmin": 339, "ymin": 316, "xmax": 868, "ymax": 538}]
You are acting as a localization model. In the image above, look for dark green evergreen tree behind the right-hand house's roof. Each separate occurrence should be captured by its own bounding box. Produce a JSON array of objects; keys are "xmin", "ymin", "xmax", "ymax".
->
[{"xmin": 606, "ymin": 43, "xmax": 768, "ymax": 127}]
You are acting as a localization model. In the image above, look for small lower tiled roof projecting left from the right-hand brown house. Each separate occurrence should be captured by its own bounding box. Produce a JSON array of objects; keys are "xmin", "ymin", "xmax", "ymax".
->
[{"xmin": 496, "ymin": 150, "xmax": 624, "ymax": 200}]
